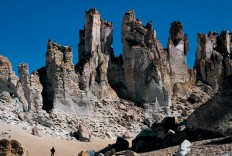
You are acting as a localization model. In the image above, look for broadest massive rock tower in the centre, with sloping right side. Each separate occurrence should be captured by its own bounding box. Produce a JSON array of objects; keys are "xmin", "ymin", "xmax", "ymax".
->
[{"xmin": 122, "ymin": 10, "xmax": 171, "ymax": 106}]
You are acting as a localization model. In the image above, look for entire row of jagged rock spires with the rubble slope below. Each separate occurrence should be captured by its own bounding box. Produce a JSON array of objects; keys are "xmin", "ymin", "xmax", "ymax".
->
[{"xmin": 0, "ymin": 8, "xmax": 232, "ymax": 145}]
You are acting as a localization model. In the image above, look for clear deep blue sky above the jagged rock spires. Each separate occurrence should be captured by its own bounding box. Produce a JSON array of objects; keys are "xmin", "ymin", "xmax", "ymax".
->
[{"xmin": 0, "ymin": 0, "xmax": 232, "ymax": 72}]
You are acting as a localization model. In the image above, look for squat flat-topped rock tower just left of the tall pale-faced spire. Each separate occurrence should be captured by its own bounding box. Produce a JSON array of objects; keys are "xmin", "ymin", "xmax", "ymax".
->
[{"xmin": 44, "ymin": 40, "xmax": 81, "ymax": 111}]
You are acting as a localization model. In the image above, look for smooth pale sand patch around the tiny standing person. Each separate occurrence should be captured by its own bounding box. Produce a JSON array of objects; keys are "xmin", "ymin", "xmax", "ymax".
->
[{"xmin": 0, "ymin": 122, "xmax": 124, "ymax": 156}]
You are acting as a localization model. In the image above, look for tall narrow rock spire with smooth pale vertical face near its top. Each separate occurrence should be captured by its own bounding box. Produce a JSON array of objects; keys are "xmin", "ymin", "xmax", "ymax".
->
[{"xmin": 75, "ymin": 8, "xmax": 118, "ymax": 100}]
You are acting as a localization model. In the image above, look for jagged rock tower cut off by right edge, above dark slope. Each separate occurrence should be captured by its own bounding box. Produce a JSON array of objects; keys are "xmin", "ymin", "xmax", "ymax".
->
[{"xmin": 195, "ymin": 31, "xmax": 232, "ymax": 91}]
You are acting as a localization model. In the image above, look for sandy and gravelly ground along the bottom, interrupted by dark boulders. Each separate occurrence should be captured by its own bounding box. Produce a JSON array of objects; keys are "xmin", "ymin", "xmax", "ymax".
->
[{"xmin": 0, "ymin": 122, "xmax": 232, "ymax": 156}]
